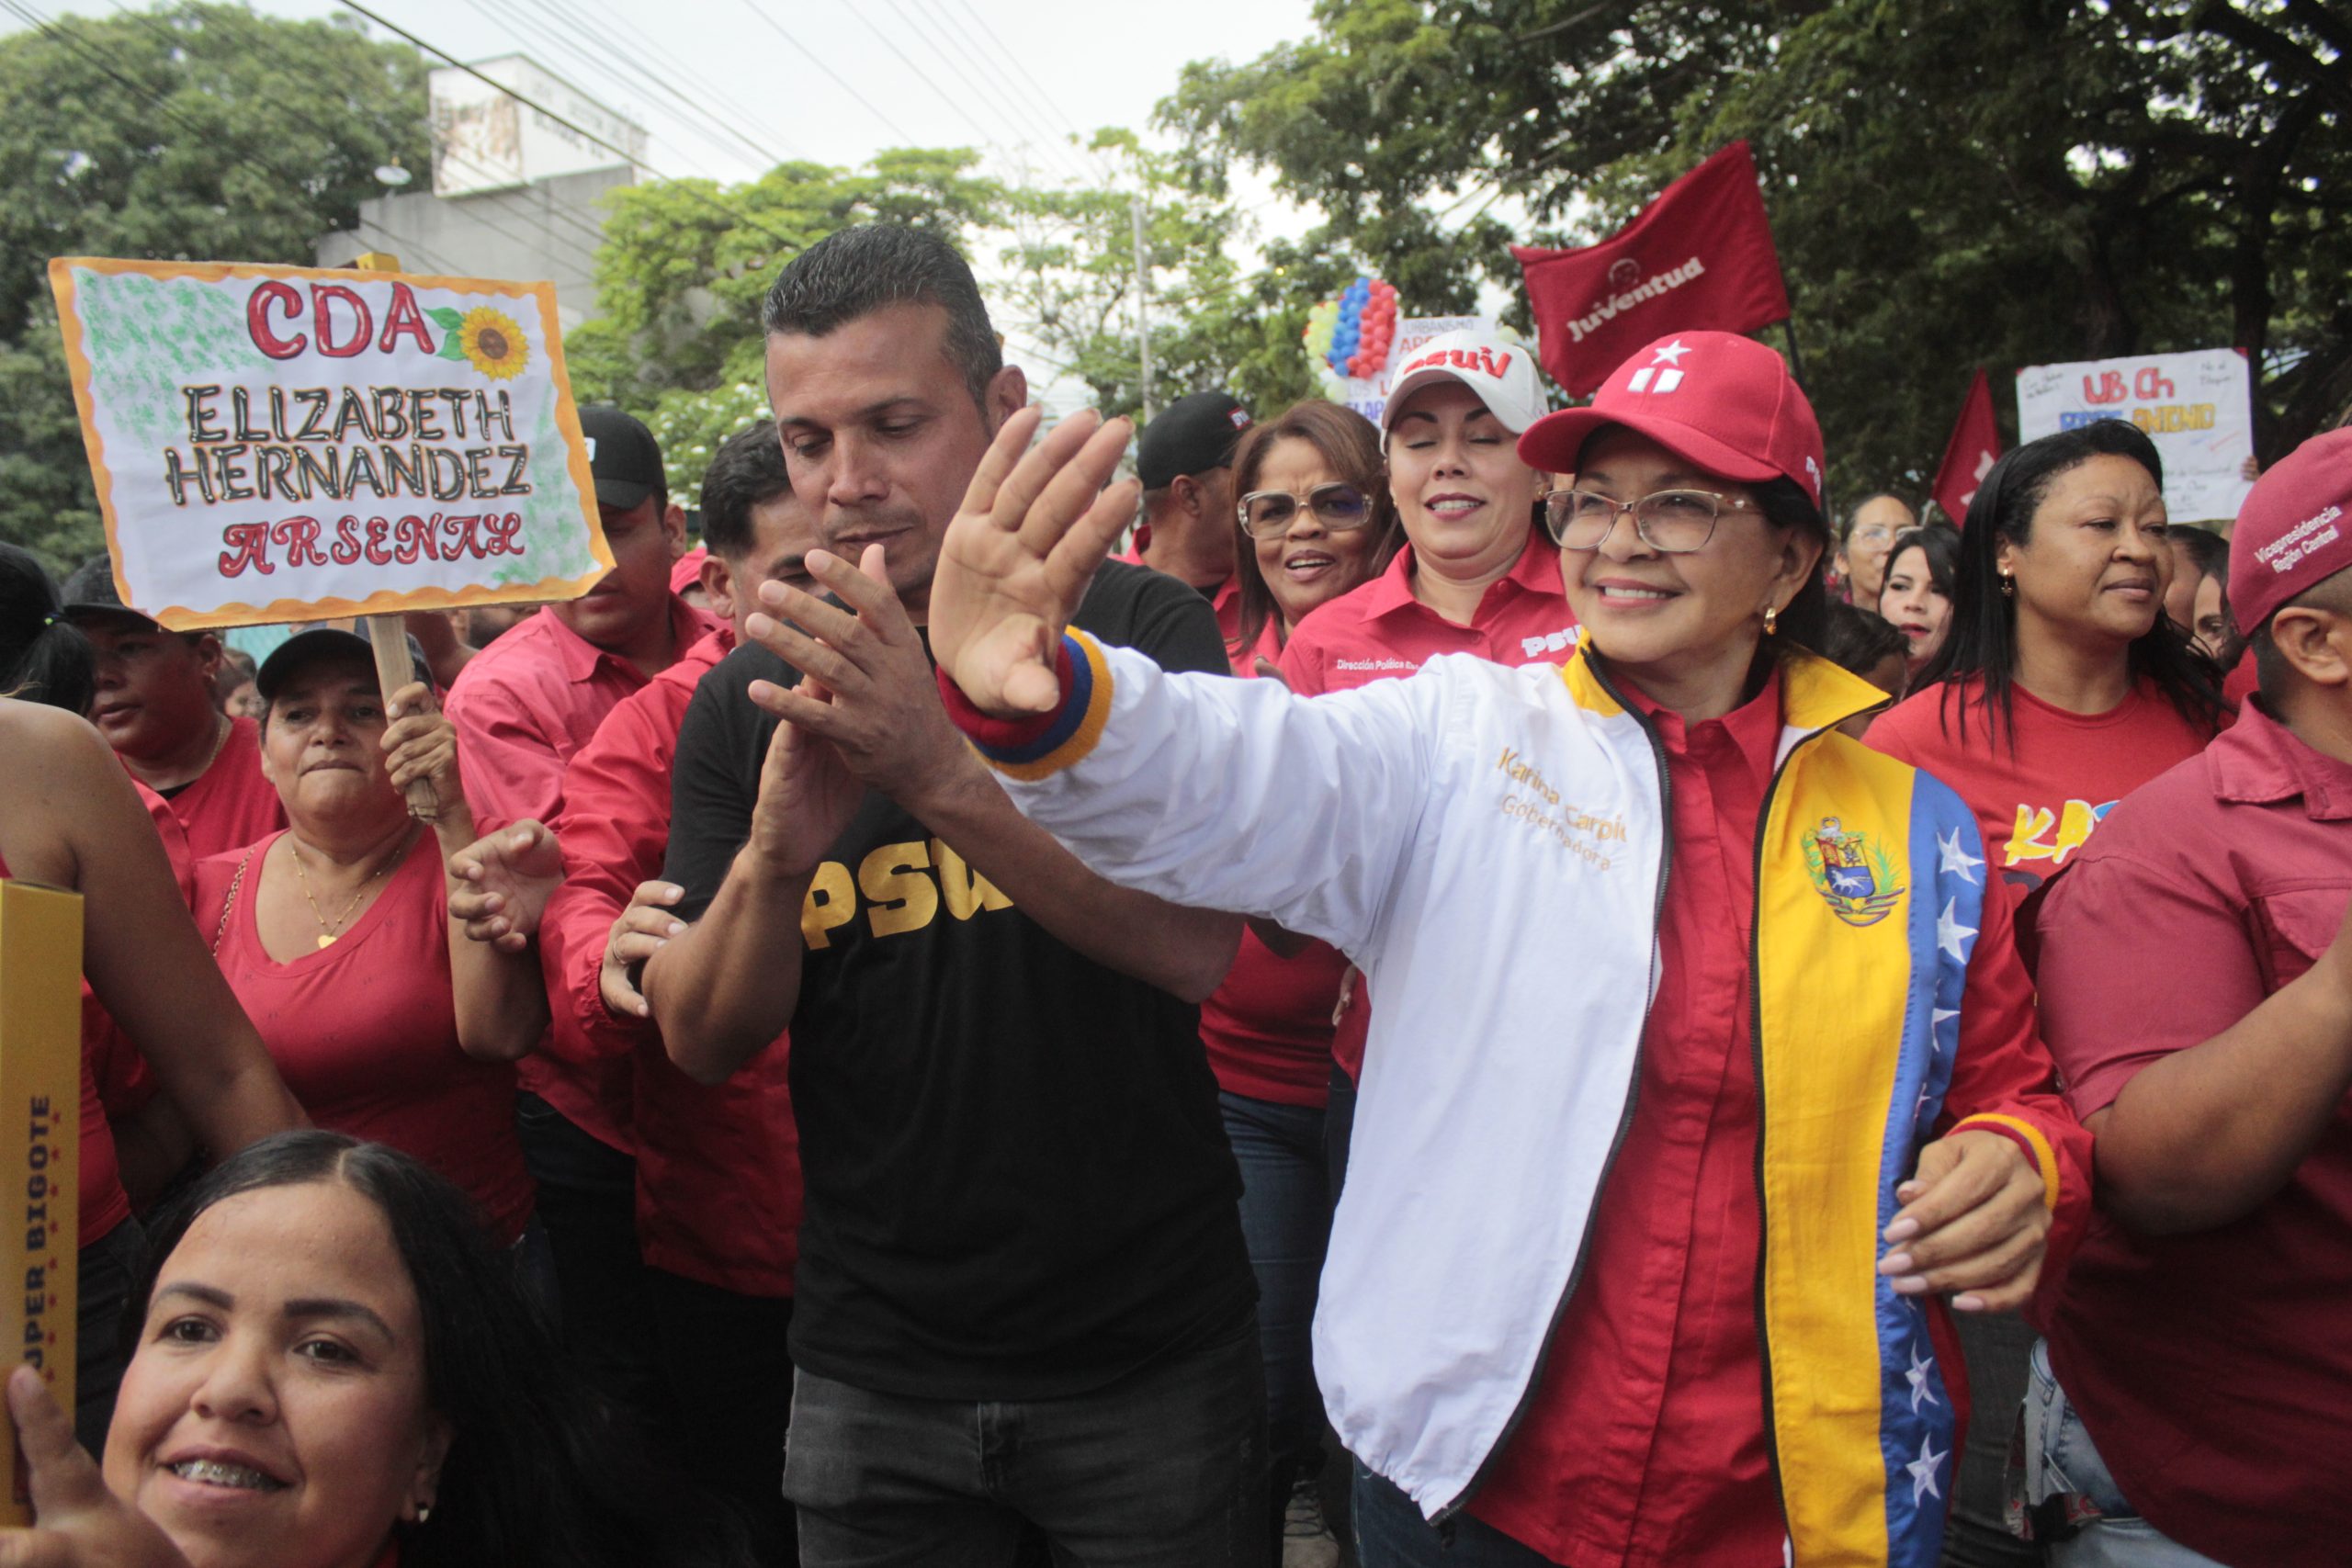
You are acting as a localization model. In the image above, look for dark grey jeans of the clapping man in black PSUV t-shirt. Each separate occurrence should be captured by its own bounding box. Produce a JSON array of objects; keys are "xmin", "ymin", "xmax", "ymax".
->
[{"xmin": 783, "ymin": 1319, "xmax": 1270, "ymax": 1568}]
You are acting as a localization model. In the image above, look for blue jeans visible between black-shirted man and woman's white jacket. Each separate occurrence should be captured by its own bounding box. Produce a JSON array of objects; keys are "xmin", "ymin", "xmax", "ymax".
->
[{"xmin": 1216, "ymin": 1093, "xmax": 1331, "ymax": 1554}]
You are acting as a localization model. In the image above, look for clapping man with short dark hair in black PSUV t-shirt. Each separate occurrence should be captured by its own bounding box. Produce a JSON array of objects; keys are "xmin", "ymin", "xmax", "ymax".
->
[{"xmin": 644, "ymin": 226, "xmax": 1265, "ymax": 1568}]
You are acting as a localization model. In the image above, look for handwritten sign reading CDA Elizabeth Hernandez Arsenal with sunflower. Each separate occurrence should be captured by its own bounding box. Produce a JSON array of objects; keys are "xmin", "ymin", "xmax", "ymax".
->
[{"xmin": 50, "ymin": 256, "xmax": 612, "ymax": 630}]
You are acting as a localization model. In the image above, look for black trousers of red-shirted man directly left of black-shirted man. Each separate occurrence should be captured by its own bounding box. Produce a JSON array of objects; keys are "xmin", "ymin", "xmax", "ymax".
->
[{"xmin": 644, "ymin": 1269, "xmax": 799, "ymax": 1563}]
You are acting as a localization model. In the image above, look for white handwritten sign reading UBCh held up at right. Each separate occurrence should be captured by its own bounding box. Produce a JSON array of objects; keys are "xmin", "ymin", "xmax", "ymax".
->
[{"xmin": 2018, "ymin": 348, "xmax": 2253, "ymax": 522}]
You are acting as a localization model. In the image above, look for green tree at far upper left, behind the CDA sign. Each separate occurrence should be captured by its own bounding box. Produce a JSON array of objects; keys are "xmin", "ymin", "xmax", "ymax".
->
[{"xmin": 0, "ymin": 0, "xmax": 428, "ymax": 569}]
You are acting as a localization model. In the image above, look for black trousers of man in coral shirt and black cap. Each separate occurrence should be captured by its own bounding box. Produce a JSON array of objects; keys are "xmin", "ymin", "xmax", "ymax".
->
[{"xmin": 515, "ymin": 1093, "xmax": 659, "ymax": 1420}]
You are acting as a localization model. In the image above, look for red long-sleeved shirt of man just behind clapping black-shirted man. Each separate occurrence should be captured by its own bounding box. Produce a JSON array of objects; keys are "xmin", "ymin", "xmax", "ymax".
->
[{"xmin": 538, "ymin": 627, "xmax": 799, "ymax": 1295}]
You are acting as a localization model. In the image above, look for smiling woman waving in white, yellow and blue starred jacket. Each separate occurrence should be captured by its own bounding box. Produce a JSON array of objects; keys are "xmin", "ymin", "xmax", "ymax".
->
[{"xmin": 908, "ymin": 332, "xmax": 2088, "ymax": 1568}]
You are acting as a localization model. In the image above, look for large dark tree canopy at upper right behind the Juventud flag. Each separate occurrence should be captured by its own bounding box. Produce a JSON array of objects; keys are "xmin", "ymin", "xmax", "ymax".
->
[{"xmin": 1159, "ymin": 0, "xmax": 2352, "ymax": 505}]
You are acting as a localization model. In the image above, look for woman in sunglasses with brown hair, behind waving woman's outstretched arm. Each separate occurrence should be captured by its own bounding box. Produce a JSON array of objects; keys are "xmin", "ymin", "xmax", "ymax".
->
[{"xmin": 1200, "ymin": 398, "xmax": 1399, "ymax": 1561}]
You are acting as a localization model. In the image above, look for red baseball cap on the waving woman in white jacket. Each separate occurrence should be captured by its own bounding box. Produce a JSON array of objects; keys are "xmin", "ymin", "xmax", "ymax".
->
[{"xmin": 1520, "ymin": 332, "xmax": 1823, "ymax": 505}]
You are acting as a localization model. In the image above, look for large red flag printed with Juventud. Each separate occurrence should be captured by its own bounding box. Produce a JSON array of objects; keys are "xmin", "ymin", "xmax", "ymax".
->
[{"xmin": 1510, "ymin": 141, "xmax": 1788, "ymax": 398}]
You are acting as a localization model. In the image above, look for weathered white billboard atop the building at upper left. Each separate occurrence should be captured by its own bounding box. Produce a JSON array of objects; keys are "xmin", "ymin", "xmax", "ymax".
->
[{"xmin": 428, "ymin": 54, "xmax": 644, "ymax": 195}]
